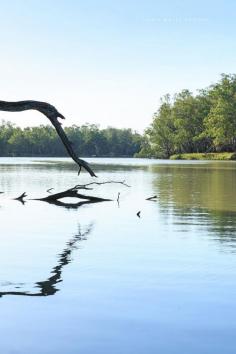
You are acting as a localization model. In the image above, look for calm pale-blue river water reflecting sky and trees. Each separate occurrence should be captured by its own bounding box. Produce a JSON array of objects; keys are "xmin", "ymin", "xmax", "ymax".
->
[{"xmin": 0, "ymin": 158, "xmax": 236, "ymax": 354}]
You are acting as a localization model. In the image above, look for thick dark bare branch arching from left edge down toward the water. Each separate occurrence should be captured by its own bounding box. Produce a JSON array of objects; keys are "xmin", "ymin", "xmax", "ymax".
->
[{"xmin": 0, "ymin": 100, "xmax": 96, "ymax": 177}]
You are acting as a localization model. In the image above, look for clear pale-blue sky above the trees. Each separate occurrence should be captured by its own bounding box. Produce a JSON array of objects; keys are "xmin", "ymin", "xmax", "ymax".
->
[{"xmin": 0, "ymin": 0, "xmax": 236, "ymax": 132}]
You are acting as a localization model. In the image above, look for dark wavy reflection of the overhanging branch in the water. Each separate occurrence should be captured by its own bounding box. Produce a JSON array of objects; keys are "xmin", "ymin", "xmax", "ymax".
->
[{"xmin": 0, "ymin": 224, "xmax": 93, "ymax": 297}]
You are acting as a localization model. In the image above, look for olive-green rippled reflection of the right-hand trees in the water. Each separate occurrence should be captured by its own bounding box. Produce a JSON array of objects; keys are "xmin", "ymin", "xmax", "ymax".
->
[{"xmin": 152, "ymin": 163, "xmax": 236, "ymax": 252}]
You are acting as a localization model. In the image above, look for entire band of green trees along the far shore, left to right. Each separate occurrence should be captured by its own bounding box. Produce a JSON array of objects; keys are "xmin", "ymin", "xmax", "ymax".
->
[{"xmin": 0, "ymin": 74, "xmax": 236, "ymax": 158}]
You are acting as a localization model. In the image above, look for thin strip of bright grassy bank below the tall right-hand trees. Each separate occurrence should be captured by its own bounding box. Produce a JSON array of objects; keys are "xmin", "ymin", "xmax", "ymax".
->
[{"xmin": 170, "ymin": 152, "xmax": 236, "ymax": 160}]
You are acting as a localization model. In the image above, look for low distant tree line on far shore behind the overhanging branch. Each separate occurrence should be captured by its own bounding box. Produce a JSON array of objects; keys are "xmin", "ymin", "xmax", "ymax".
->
[{"xmin": 0, "ymin": 121, "xmax": 142, "ymax": 157}]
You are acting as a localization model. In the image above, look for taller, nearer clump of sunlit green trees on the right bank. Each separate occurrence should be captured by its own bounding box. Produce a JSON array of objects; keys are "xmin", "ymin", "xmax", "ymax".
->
[{"xmin": 138, "ymin": 74, "xmax": 236, "ymax": 158}]
